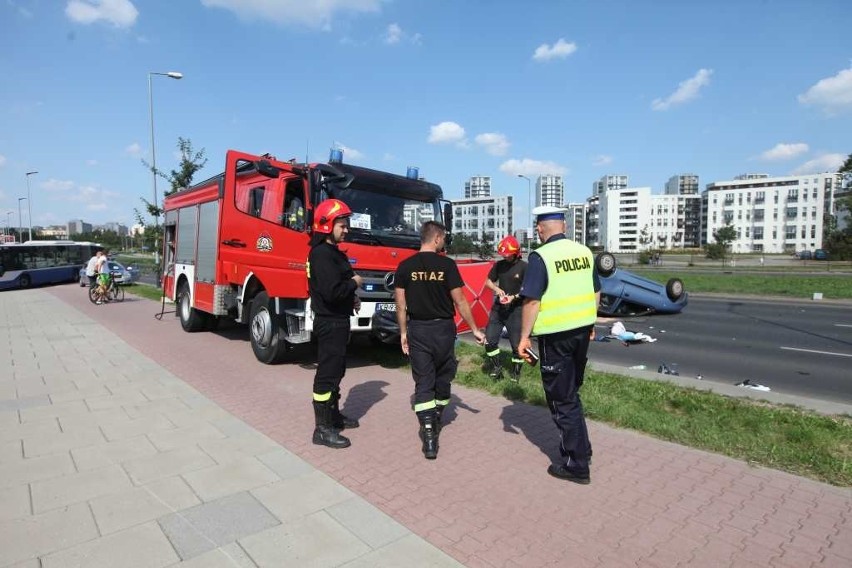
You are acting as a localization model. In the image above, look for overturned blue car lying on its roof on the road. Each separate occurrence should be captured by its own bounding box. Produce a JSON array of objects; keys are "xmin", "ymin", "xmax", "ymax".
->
[{"xmin": 595, "ymin": 252, "xmax": 688, "ymax": 316}]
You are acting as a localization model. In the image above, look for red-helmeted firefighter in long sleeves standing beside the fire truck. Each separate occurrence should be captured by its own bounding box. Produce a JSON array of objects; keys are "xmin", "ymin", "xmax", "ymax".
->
[{"xmin": 307, "ymin": 199, "xmax": 361, "ymax": 448}]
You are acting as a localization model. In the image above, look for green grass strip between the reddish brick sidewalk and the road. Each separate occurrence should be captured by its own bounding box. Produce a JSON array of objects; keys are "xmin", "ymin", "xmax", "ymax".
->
[{"xmin": 364, "ymin": 342, "xmax": 852, "ymax": 487}]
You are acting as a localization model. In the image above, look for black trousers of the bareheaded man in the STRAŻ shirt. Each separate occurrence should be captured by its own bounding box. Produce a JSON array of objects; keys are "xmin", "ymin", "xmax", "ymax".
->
[{"xmin": 408, "ymin": 319, "xmax": 458, "ymax": 410}]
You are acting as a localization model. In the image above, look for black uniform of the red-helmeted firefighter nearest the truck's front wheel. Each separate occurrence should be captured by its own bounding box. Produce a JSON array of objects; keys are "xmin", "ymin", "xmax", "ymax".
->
[{"xmin": 308, "ymin": 240, "xmax": 358, "ymax": 438}]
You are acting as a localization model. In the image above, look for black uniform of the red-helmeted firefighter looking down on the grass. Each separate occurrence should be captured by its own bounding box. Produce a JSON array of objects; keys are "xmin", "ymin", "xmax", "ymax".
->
[{"xmin": 485, "ymin": 257, "xmax": 527, "ymax": 380}]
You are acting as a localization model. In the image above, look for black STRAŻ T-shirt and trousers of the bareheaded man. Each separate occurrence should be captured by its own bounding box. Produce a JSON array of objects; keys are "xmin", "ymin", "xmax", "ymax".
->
[{"xmin": 396, "ymin": 252, "xmax": 464, "ymax": 414}]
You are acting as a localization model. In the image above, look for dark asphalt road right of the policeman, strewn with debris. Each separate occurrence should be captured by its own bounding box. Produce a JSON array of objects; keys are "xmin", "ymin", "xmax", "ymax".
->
[{"xmin": 590, "ymin": 296, "xmax": 852, "ymax": 403}]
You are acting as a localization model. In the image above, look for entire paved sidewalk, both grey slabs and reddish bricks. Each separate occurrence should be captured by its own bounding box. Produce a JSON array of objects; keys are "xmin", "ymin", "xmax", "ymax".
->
[{"xmin": 0, "ymin": 286, "xmax": 852, "ymax": 567}]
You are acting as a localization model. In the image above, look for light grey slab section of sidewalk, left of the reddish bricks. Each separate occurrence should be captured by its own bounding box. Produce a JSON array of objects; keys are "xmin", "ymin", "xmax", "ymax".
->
[{"xmin": 0, "ymin": 287, "xmax": 458, "ymax": 568}]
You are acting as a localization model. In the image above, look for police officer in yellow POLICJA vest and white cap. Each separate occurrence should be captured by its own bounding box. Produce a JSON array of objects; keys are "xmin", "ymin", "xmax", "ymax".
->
[{"xmin": 518, "ymin": 206, "xmax": 600, "ymax": 484}]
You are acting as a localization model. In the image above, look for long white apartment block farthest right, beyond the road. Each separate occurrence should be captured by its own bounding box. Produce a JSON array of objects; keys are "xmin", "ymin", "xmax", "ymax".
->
[{"xmin": 701, "ymin": 173, "xmax": 842, "ymax": 253}]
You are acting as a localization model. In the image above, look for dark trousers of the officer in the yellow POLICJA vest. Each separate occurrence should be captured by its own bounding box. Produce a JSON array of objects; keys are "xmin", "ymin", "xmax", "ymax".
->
[{"xmin": 538, "ymin": 327, "xmax": 592, "ymax": 470}]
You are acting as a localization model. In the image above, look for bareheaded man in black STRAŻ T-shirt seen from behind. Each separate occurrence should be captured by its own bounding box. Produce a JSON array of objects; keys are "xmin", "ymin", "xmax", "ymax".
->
[{"xmin": 394, "ymin": 221, "xmax": 485, "ymax": 460}]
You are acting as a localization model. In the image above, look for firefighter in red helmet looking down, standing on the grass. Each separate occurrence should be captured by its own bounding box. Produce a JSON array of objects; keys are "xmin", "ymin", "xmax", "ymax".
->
[{"xmin": 485, "ymin": 235, "xmax": 527, "ymax": 382}]
